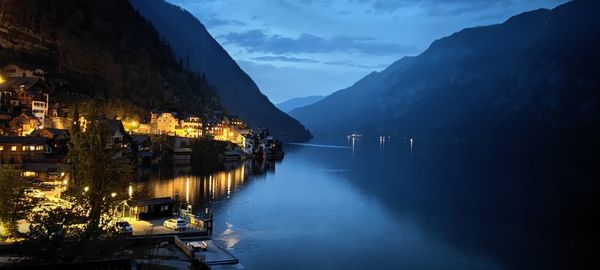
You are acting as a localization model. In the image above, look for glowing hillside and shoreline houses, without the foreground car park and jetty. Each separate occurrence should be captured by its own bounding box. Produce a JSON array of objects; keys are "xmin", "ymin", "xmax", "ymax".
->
[{"xmin": 0, "ymin": 64, "xmax": 283, "ymax": 176}]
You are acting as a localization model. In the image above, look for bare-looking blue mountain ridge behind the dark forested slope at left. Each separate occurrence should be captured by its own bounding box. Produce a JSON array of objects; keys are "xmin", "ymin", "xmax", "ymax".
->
[{"xmin": 131, "ymin": 0, "xmax": 310, "ymax": 141}]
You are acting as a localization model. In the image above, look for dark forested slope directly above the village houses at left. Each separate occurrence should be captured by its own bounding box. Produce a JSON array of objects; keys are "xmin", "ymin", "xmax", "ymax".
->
[{"xmin": 0, "ymin": 0, "xmax": 221, "ymax": 118}]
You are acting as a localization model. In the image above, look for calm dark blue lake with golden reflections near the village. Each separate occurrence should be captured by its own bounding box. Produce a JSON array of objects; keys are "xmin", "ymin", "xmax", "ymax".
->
[{"xmin": 137, "ymin": 136, "xmax": 591, "ymax": 269}]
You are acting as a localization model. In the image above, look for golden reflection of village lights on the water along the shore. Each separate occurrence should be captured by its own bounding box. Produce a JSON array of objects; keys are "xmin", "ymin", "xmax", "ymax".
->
[{"xmin": 134, "ymin": 161, "xmax": 276, "ymax": 212}]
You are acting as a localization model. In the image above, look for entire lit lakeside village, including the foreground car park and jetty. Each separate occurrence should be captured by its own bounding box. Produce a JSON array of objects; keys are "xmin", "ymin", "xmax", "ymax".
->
[{"xmin": 0, "ymin": 64, "xmax": 284, "ymax": 265}]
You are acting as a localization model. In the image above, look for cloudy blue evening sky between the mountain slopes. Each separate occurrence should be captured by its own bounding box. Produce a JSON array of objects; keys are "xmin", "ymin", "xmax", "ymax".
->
[{"xmin": 168, "ymin": 0, "xmax": 567, "ymax": 103}]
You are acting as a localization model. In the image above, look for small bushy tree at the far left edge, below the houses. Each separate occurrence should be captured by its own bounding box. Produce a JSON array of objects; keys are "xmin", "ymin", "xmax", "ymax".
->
[{"xmin": 0, "ymin": 165, "xmax": 28, "ymax": 237}]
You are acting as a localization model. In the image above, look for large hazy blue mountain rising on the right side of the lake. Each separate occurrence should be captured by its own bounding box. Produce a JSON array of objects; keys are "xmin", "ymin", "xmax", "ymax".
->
[{"xmin": 290, "ymin": 0, "xmax": 600, "ymax": 140}]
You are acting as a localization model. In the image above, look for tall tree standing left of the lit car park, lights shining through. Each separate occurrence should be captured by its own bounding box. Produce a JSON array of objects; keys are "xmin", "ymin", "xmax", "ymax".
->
[{"xmin": 68, "ymin": 107, "xmax": 133, "ymax": 240}]
